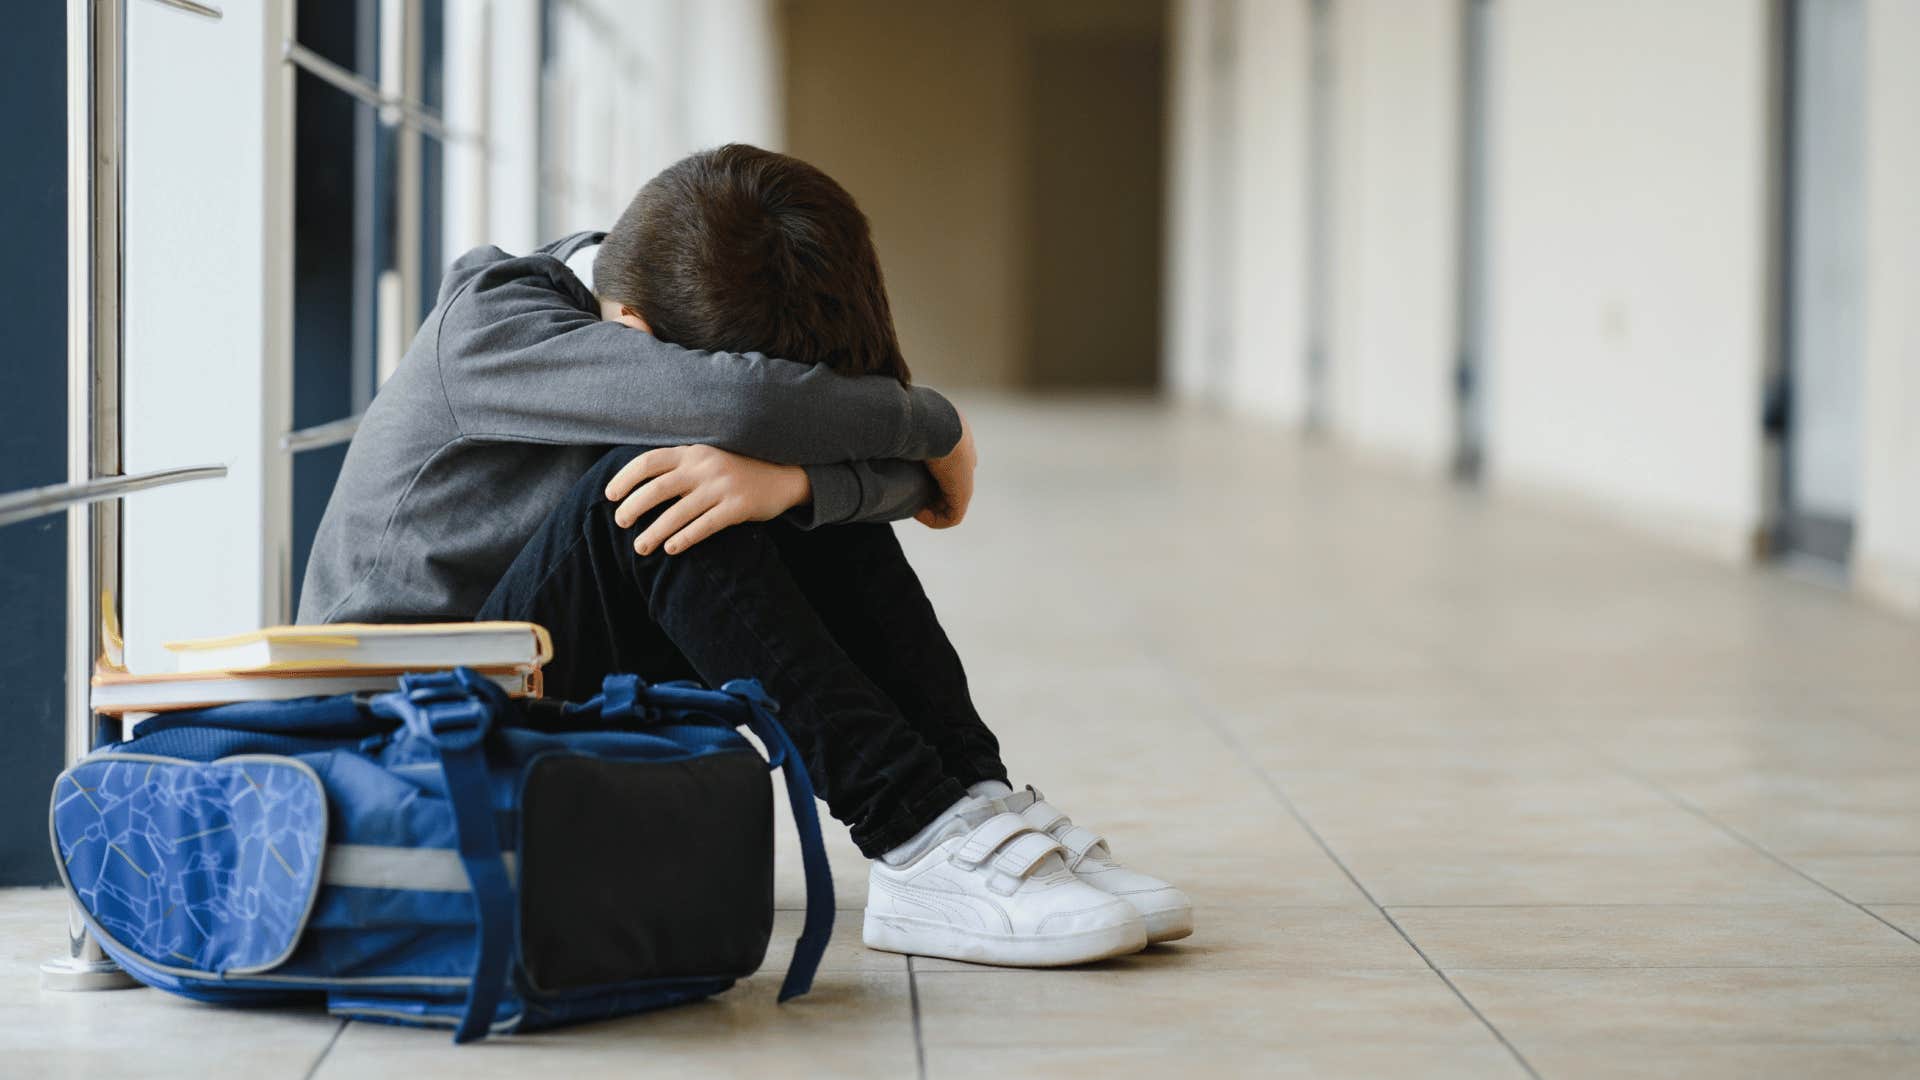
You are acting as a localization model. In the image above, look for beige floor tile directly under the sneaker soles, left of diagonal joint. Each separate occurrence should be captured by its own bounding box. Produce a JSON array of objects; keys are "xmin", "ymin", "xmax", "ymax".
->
[{"xmin": 914, "ymin": 907, "xmax": 1427, "ymax": 982}]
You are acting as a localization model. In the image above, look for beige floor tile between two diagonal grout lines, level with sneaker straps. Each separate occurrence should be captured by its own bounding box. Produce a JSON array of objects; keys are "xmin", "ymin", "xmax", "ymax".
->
[{"xmin": 1342, "ymin": 846, "xmax": 1832, "ymax": 907}]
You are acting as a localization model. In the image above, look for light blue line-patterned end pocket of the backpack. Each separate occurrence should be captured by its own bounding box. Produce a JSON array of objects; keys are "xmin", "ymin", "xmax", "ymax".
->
[{"xmin": 54, "ymin": 755, "xmax": 326, "ymax": 974}]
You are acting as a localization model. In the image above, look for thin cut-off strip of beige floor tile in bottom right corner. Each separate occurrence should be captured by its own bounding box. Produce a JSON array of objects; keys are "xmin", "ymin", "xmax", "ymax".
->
[{"xmin": 1523, "ymin": 1042, "xmax": 1920, "ymax": 1080}]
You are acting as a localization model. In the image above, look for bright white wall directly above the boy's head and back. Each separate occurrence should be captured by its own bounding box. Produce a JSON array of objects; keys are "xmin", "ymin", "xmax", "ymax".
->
[{"xmin": 444, "ymin": 0, "xmax": 781, "ymax": 258}]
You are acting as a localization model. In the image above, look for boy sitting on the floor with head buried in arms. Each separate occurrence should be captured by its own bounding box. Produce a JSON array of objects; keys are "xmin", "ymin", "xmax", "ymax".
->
[{"xmin": 301, "ymin": 146, "xmax": 1192, "ymax": 967}]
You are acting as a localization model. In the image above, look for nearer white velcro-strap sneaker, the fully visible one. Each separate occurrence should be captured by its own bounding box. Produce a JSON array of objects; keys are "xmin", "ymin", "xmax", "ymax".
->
[{"xmin": 862, "ymin": 813, "xmax": 1146, "ymax": 967}]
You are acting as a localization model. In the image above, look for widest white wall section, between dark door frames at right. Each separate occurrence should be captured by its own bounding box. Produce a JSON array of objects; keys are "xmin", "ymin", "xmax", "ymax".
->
[{"xmin": 1488, "ymin": 0, "xmax": 1768, "ymax": 559}]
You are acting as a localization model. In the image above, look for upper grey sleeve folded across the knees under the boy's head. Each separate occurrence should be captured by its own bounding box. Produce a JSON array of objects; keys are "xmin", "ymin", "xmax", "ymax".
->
[{"xmin": 434, "ymin": 248, "xmax": 960, "ymax": 465}]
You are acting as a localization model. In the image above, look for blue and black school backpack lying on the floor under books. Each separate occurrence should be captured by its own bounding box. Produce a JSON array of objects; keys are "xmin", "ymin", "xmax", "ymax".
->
[{"xmin": 52, "ymin": 669, "xmax": 833, "ymax": 1042}]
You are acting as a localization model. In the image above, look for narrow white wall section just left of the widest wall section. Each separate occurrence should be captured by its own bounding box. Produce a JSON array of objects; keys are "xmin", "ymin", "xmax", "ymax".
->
[{"xmin": 1329, "ymin": 0, "xmax": 1461, "ymax": 469}]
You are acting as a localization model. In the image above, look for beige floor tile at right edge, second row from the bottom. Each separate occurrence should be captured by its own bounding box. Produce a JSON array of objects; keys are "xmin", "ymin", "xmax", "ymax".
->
[{"xmin": 1452, "ymin": 967, "xmax": 1920, "ymax": 1053}]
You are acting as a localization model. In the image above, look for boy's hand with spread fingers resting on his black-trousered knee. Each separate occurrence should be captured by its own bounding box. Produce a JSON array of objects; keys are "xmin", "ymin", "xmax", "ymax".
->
[{"xmin": 607, "ymin": 446, "xmax": 814, "ymax": 555}]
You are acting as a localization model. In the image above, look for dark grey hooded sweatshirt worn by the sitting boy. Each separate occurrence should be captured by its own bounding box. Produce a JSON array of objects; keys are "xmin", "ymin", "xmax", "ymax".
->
[{"xmin": 300, "ymin": 233, "xmax": 960, "ymax": 623}]
